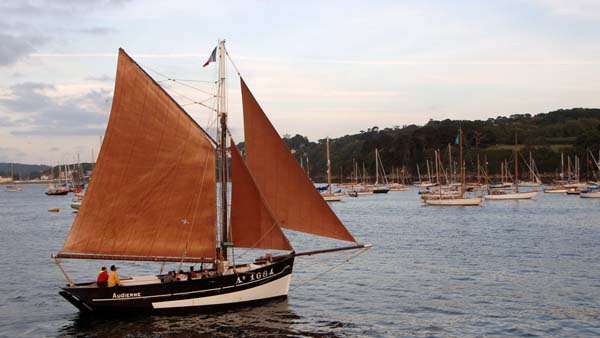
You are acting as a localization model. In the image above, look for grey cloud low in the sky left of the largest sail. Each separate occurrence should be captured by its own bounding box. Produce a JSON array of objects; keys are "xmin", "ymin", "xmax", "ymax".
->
[{"xmin": 0, "ymin": 82, "xmax": 110, "ymax": 136}]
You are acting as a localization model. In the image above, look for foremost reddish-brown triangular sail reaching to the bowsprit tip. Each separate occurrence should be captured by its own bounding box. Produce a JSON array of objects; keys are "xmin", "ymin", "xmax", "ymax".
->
[{"xmin": 240, "ymin": 78, "xmax": 355, "ymax": 242}]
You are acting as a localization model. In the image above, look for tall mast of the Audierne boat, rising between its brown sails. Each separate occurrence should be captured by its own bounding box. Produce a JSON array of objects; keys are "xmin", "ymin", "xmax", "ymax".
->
[{"xmin": 217, "ymin": 40, "xmax": 229, "ymax": 260}]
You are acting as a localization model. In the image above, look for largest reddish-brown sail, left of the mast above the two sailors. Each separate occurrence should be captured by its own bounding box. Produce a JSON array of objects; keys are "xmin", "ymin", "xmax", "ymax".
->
[{"xmin": 58, "ymin": 50, "xmax": 216, "ymax": 260}]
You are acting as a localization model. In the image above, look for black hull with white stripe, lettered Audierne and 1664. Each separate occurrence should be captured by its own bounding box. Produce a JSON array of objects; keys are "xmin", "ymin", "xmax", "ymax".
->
[{"xmin": 59, "ymin": 258, "xmax": 294, "ymax": 315}]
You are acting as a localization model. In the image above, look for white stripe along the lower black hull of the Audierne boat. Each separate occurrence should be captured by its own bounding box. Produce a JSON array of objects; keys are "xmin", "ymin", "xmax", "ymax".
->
[{"xmin": 152, "ymin": 274, "xmax": 292, "ymax": 309}]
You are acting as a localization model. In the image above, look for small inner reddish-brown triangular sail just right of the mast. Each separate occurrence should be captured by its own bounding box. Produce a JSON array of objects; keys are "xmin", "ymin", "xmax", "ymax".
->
[{"xmin": 230, "ymin": 140, "xmax": 292, "ymax": 250}]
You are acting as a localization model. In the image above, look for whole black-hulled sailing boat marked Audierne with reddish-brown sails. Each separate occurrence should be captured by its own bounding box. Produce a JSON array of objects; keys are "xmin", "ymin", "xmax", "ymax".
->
[{"xmin": 52, "ymin": 44, "xmax": 369, "ymax": 313}]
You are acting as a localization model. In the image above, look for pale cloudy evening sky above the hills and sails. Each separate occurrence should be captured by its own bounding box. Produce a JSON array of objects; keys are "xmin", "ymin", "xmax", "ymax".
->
[{"xmin": 0, "ymin": 0, "xmax": 600, "ymax": 164}]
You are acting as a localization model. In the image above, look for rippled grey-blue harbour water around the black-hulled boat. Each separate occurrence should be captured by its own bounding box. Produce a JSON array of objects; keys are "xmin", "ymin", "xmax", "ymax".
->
[{"xmin": 0, "ymin": 186, "xmax": 600, "ymax": 337}]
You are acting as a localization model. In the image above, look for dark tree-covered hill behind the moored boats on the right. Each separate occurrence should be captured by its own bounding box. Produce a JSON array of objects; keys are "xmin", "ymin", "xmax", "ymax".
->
[{"xmin": 276, "ymin": 108, "xmax": 600, "ymax": 181}]
